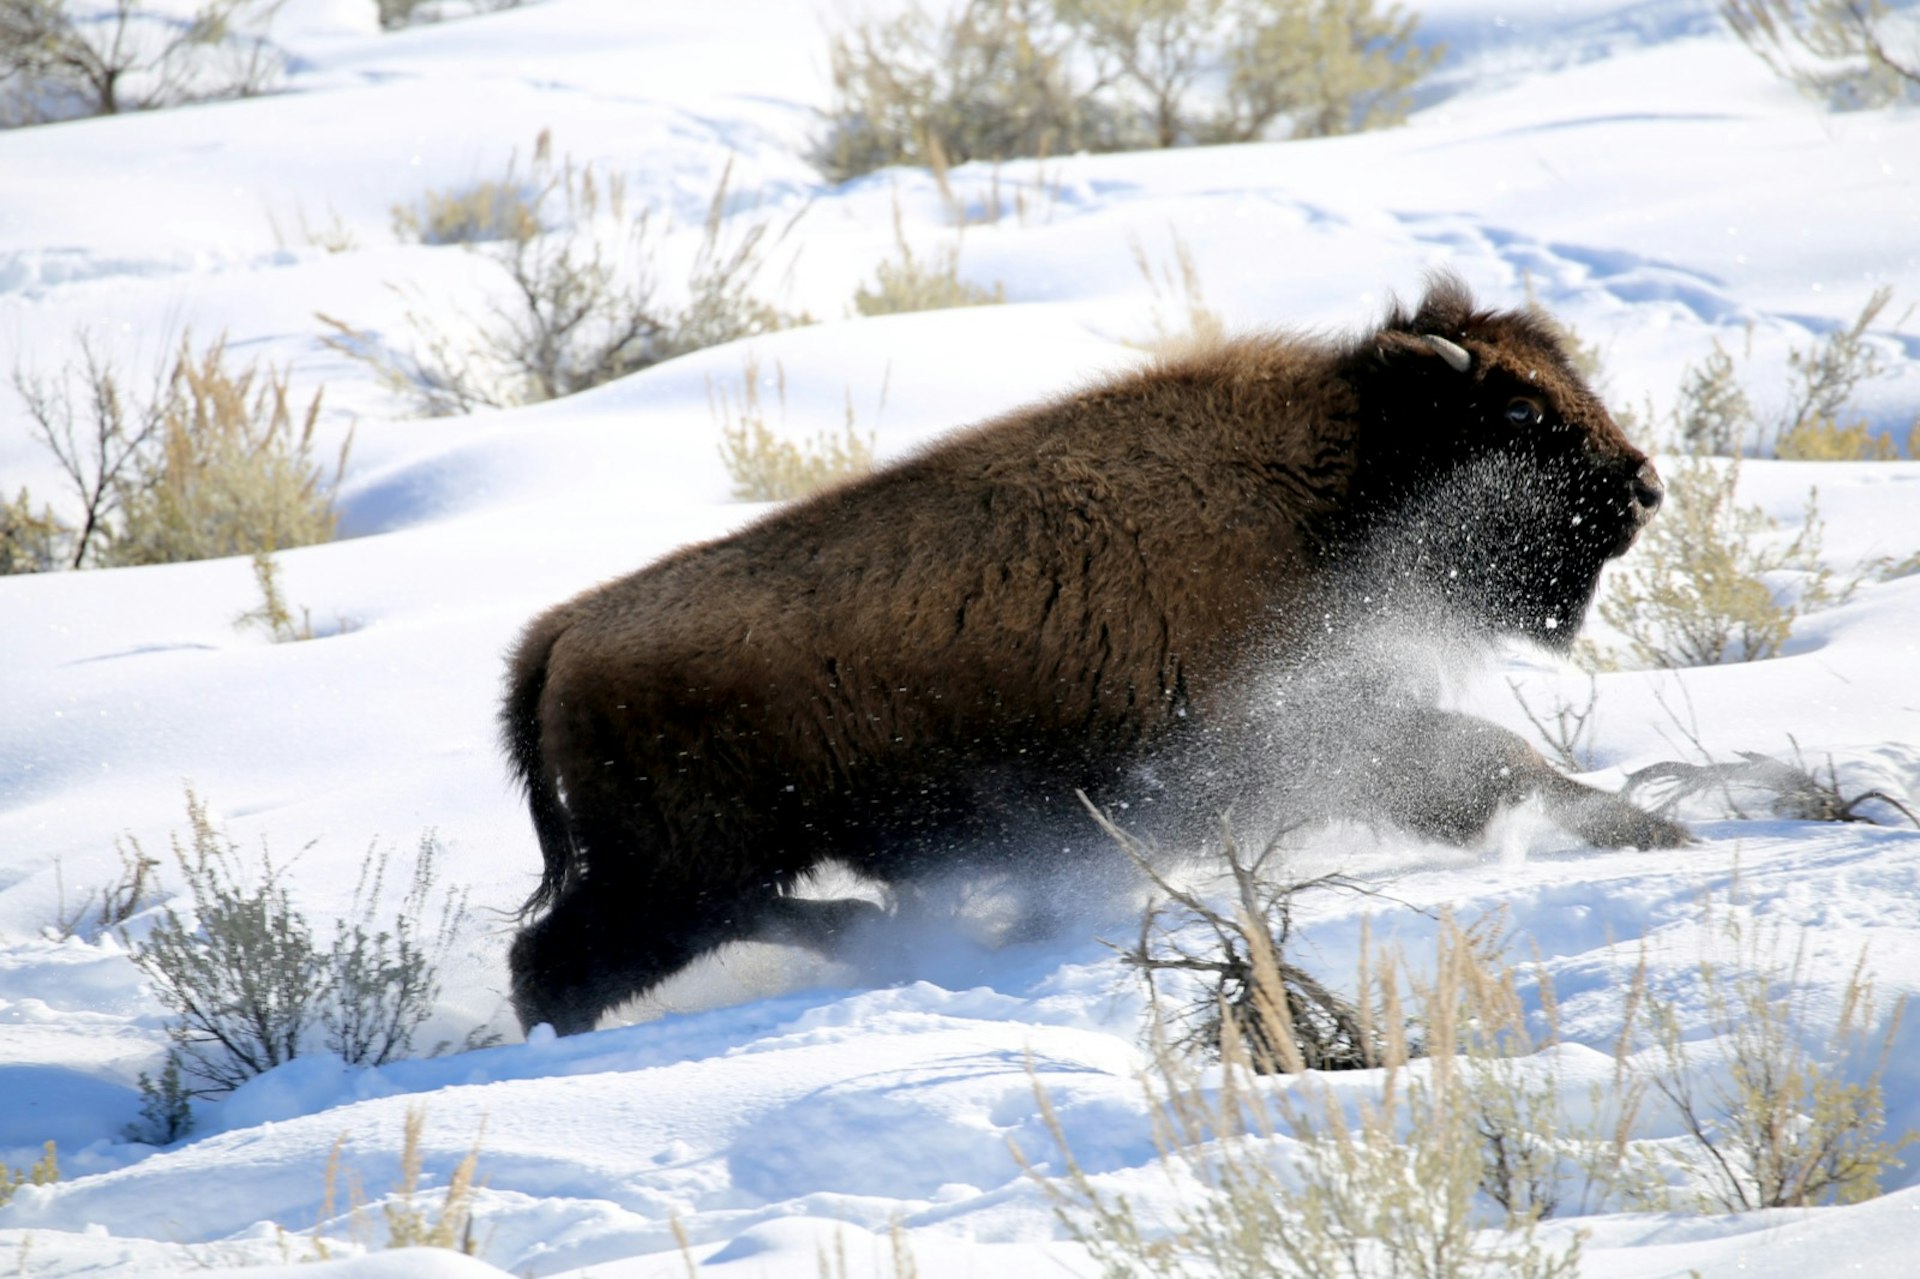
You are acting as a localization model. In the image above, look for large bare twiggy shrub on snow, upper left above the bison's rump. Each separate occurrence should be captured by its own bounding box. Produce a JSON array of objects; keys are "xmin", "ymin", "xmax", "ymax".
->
[{"xmin": 319, "ymin": 131, "xmax": 808, "ymax": 417}]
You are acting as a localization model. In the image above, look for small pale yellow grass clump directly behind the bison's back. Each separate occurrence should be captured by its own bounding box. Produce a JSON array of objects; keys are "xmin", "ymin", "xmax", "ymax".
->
[{"xmin": 707, "ymin": 355, "xmax": 885, "ymax": 501}]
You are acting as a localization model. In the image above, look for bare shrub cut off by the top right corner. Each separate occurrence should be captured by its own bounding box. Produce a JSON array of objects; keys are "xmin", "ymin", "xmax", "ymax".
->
[{"xmin": 1720, "ymin": 0, "xmax": 1920, "ymax": 109}]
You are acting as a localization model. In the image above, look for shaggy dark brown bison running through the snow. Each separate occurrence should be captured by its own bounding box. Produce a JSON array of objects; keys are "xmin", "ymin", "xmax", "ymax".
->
[{"xmin": 501, "ymin": 278, "xmax": 1686, "ymax": 1033}]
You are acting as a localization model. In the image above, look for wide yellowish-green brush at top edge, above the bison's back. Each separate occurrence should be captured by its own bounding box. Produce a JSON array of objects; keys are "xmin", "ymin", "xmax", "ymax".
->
[{"xmin": 814, "ymin": 0, "xmax": 1438, "ymax": 181}]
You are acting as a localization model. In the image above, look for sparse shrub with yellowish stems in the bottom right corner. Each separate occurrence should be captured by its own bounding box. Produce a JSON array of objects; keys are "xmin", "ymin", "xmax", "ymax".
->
[{"xmin": 1628, "ymin": 887, "xmax": 1914, "ymax": 1212}]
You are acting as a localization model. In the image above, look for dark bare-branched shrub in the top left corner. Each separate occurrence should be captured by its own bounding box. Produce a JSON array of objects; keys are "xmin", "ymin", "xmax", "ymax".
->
[{"xmin": 0, "ymin": 0, "xmax": 286, "ymax": 125}]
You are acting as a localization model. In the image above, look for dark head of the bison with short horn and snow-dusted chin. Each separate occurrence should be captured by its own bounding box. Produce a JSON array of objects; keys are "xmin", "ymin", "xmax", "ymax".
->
[{"xmin": 1344, "ymin": 278, "xmax": 1663, "ymax": 647}]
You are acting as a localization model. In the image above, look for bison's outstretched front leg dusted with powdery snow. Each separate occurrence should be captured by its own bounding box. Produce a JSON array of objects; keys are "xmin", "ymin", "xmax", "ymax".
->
[{"xmin": 1377, "ymin": 711, "xmax": 1693, "ymax": 849}]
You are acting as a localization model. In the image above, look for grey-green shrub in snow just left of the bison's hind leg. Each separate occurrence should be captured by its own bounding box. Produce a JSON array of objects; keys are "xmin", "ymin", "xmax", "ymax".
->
[{"xmin": 132, "ymin": 789, "xmax": 467, "ymax": 1097}]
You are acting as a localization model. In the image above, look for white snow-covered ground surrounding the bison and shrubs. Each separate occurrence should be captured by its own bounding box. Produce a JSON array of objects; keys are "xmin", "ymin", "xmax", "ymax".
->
[{"xmin": 0, "ymin": 0, "xmax": 1920, "ymax": 1279}]
